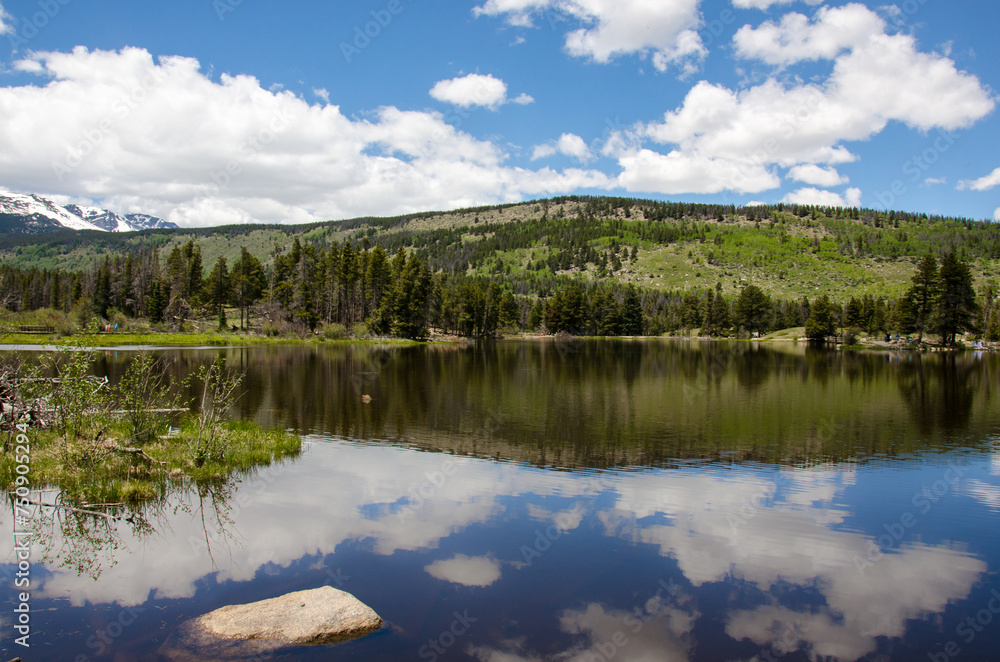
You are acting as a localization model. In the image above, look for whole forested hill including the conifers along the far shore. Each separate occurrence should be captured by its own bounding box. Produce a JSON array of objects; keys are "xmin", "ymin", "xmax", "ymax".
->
[{"xmin": 0, "ymin": 197, "xmax": 1000, "ymax": 343}]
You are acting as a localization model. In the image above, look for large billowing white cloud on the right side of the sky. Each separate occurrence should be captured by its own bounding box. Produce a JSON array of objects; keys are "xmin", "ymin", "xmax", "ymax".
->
[{"xmin": 605, "ymin": 5, "xmax": 995, "ymax": 197}]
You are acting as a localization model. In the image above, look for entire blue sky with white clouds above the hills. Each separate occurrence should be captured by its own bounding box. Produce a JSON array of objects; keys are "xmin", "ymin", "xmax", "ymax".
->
[{"xmin": 0, "ymin": 0, "xmax": 1000, "ymax": 226}]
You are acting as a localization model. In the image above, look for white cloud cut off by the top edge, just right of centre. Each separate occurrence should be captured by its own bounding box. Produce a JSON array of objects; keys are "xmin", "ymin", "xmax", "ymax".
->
[{"xmin": 473, "ymin": 0, "xmax": 707, "ymax": 71}]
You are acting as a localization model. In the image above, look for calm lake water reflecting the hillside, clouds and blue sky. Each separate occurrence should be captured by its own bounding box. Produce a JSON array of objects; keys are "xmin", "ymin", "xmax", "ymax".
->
[{"xmin": 0, "ymin": 341, "xmax": 1000, "ymax": 662}]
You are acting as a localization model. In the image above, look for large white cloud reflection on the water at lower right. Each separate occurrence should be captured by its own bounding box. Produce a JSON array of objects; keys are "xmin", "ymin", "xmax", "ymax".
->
[{"xmin": 602, "ymin": 467, "xmax": 987, "ymax": 660}]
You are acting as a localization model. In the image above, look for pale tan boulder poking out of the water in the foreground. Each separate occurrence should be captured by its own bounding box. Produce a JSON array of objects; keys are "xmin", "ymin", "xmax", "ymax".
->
[{"xmin": 160, "ymin": 586, "xmax": 382, "ymax": 661}]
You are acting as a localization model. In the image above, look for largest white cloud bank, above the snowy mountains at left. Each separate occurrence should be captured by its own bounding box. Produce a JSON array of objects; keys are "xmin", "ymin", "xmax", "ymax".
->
[{"xmin": 0, "ymin": 47, "xmax": 614, "ymax": 226}]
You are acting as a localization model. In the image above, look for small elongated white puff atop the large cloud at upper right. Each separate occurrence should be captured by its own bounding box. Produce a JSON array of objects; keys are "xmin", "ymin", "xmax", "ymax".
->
[{"xmin": 733, "ymin": 4, "xmax": 885, "ymax": 65}]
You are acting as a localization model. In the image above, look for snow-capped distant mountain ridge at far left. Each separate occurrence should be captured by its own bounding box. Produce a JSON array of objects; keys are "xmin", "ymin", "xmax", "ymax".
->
[{"xmin": 0, "ymin": 193, "xmax": 178, "ymax": 234}]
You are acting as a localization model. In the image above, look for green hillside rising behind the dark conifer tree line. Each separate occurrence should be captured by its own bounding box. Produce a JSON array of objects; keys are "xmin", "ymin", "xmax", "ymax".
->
[{"xmin": 0, "ymin": 196, "xmax": 1000, "ymax": 299}]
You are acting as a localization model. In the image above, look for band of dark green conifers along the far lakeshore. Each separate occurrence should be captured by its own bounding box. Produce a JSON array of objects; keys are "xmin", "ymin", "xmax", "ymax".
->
[{"xmin": 0, "ymin": 236, "xmax": 984, "ymax": 343}]
